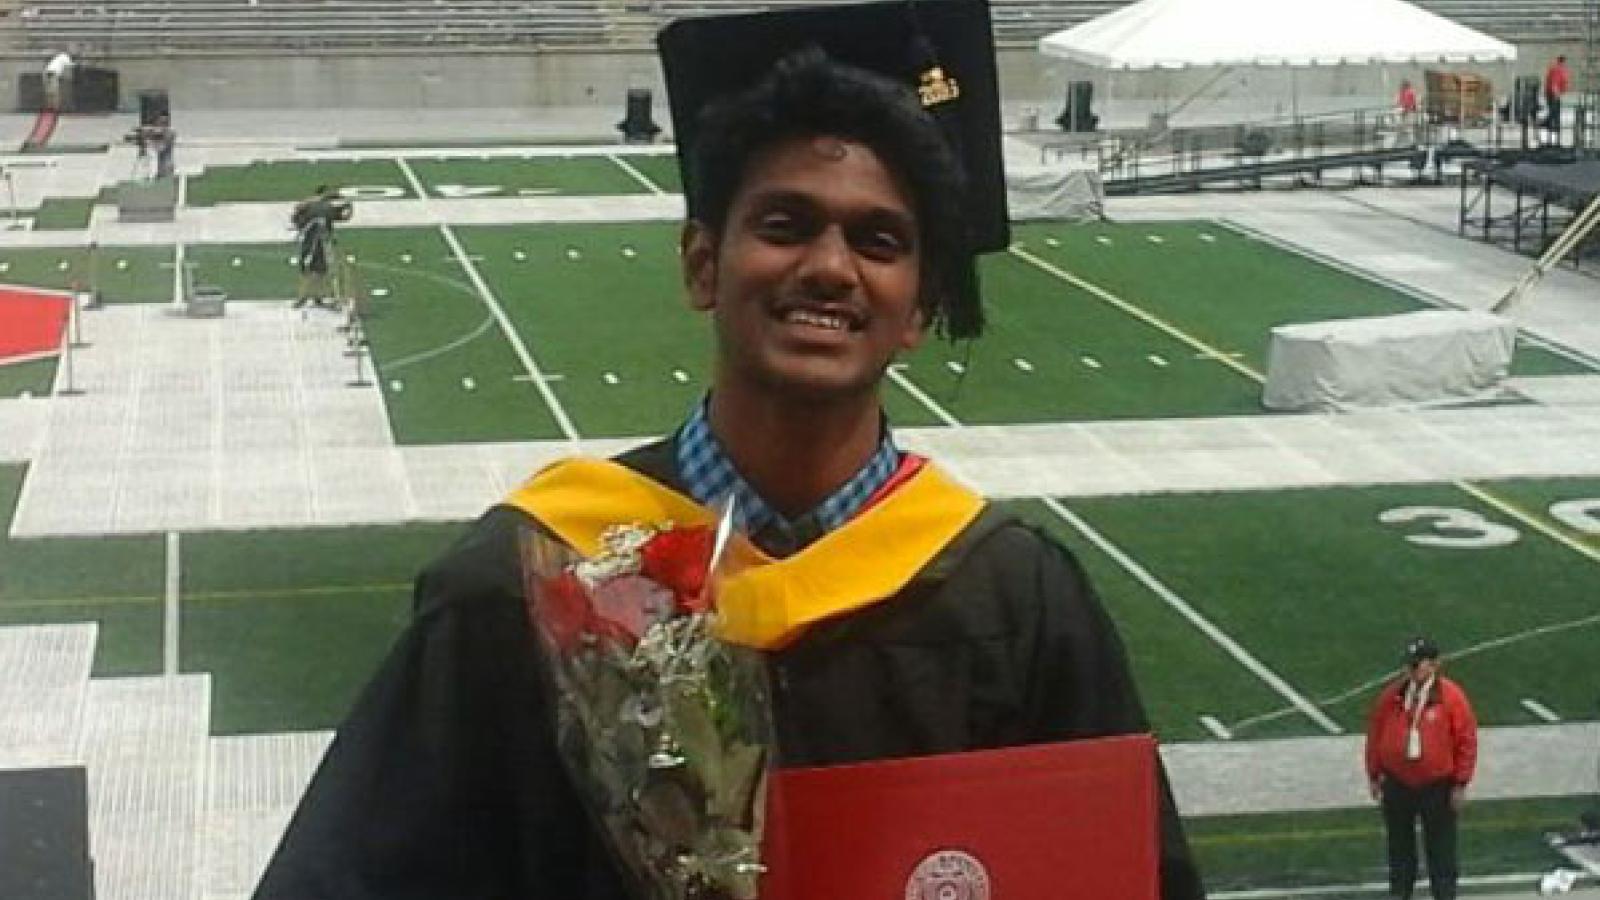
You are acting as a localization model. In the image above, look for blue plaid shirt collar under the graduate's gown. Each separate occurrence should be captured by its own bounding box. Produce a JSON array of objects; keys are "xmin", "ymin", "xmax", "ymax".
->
[{"xmin": 677, "ymin": 400, "xmax": 901, "ymax": 556}]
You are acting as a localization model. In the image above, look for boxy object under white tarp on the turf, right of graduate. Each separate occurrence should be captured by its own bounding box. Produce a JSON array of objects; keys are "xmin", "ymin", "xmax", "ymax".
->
[{"xmin": 1261, "ymin": 309, "xmax": 1517, "ymax": 412}]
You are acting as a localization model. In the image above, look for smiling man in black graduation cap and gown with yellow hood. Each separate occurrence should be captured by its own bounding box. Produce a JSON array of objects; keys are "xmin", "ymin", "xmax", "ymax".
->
[{"xmin": 256, "ymin": 0, "xmax": 1202, "ymax": 900}]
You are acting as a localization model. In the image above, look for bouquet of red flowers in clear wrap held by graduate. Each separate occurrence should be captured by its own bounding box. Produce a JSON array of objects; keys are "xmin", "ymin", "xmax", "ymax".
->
[{"xmin": 523, "ymin": 514, "xmax": 773, "ymax": 900}]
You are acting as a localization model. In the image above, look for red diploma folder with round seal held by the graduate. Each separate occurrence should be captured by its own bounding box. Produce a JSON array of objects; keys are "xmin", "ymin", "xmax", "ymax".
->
[{"xmin": 762, "ymin": 735, "xmax": 1160, "ymax": 900}]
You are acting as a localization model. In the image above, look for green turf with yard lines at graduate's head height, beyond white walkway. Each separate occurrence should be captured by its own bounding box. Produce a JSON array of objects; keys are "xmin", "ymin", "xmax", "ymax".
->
[{"xmin": 0, "ymin": 217, "xmax": 1589, "ymax": 444}]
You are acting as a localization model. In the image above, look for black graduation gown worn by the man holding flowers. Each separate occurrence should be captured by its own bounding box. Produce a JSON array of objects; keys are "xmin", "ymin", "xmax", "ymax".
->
[{"xmin": 256, "ymin": 440, "xmax": 1203, "ymax": 900}]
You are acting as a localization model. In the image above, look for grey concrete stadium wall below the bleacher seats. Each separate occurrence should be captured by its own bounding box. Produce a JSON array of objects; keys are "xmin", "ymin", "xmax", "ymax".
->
[{"xmin": 0, "ymin": 43, "xmax": 1582, "ymax": 110}]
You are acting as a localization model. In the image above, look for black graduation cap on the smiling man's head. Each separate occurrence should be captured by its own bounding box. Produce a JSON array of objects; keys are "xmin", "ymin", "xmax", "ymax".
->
[{"xmin": 656, "ymin": 0, "xmax": 1011, "ymax": 253}]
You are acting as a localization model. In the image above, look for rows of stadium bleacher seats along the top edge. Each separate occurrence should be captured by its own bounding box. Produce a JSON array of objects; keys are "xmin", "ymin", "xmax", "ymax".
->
[{"xmin": 14, "ymin": 0, "xmax": 1586, "ymax": 54}]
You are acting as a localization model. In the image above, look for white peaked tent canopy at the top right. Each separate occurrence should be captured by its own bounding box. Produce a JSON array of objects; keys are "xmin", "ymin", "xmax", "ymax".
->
[{"xmin": 1038, "ymin": 0, "xmax": 1517, "ymax": 69}]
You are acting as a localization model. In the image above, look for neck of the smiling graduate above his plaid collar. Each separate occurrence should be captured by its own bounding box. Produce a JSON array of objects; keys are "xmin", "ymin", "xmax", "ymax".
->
[{"xmin": 709, "ymin": 379, "xmax": 882, "ymax": 517}]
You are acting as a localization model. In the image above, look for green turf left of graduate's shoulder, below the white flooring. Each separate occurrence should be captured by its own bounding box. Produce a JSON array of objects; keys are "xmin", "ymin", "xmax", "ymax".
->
[{"xmin": 0, "ymin": 466, "xmax": 461, "ymax": 733}]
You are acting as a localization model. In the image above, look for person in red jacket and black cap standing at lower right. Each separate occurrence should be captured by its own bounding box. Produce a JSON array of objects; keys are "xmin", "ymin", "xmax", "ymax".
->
[{"xmin": 1366, "ymin": 637, "xmax": 1478, "ymax": 900}]
